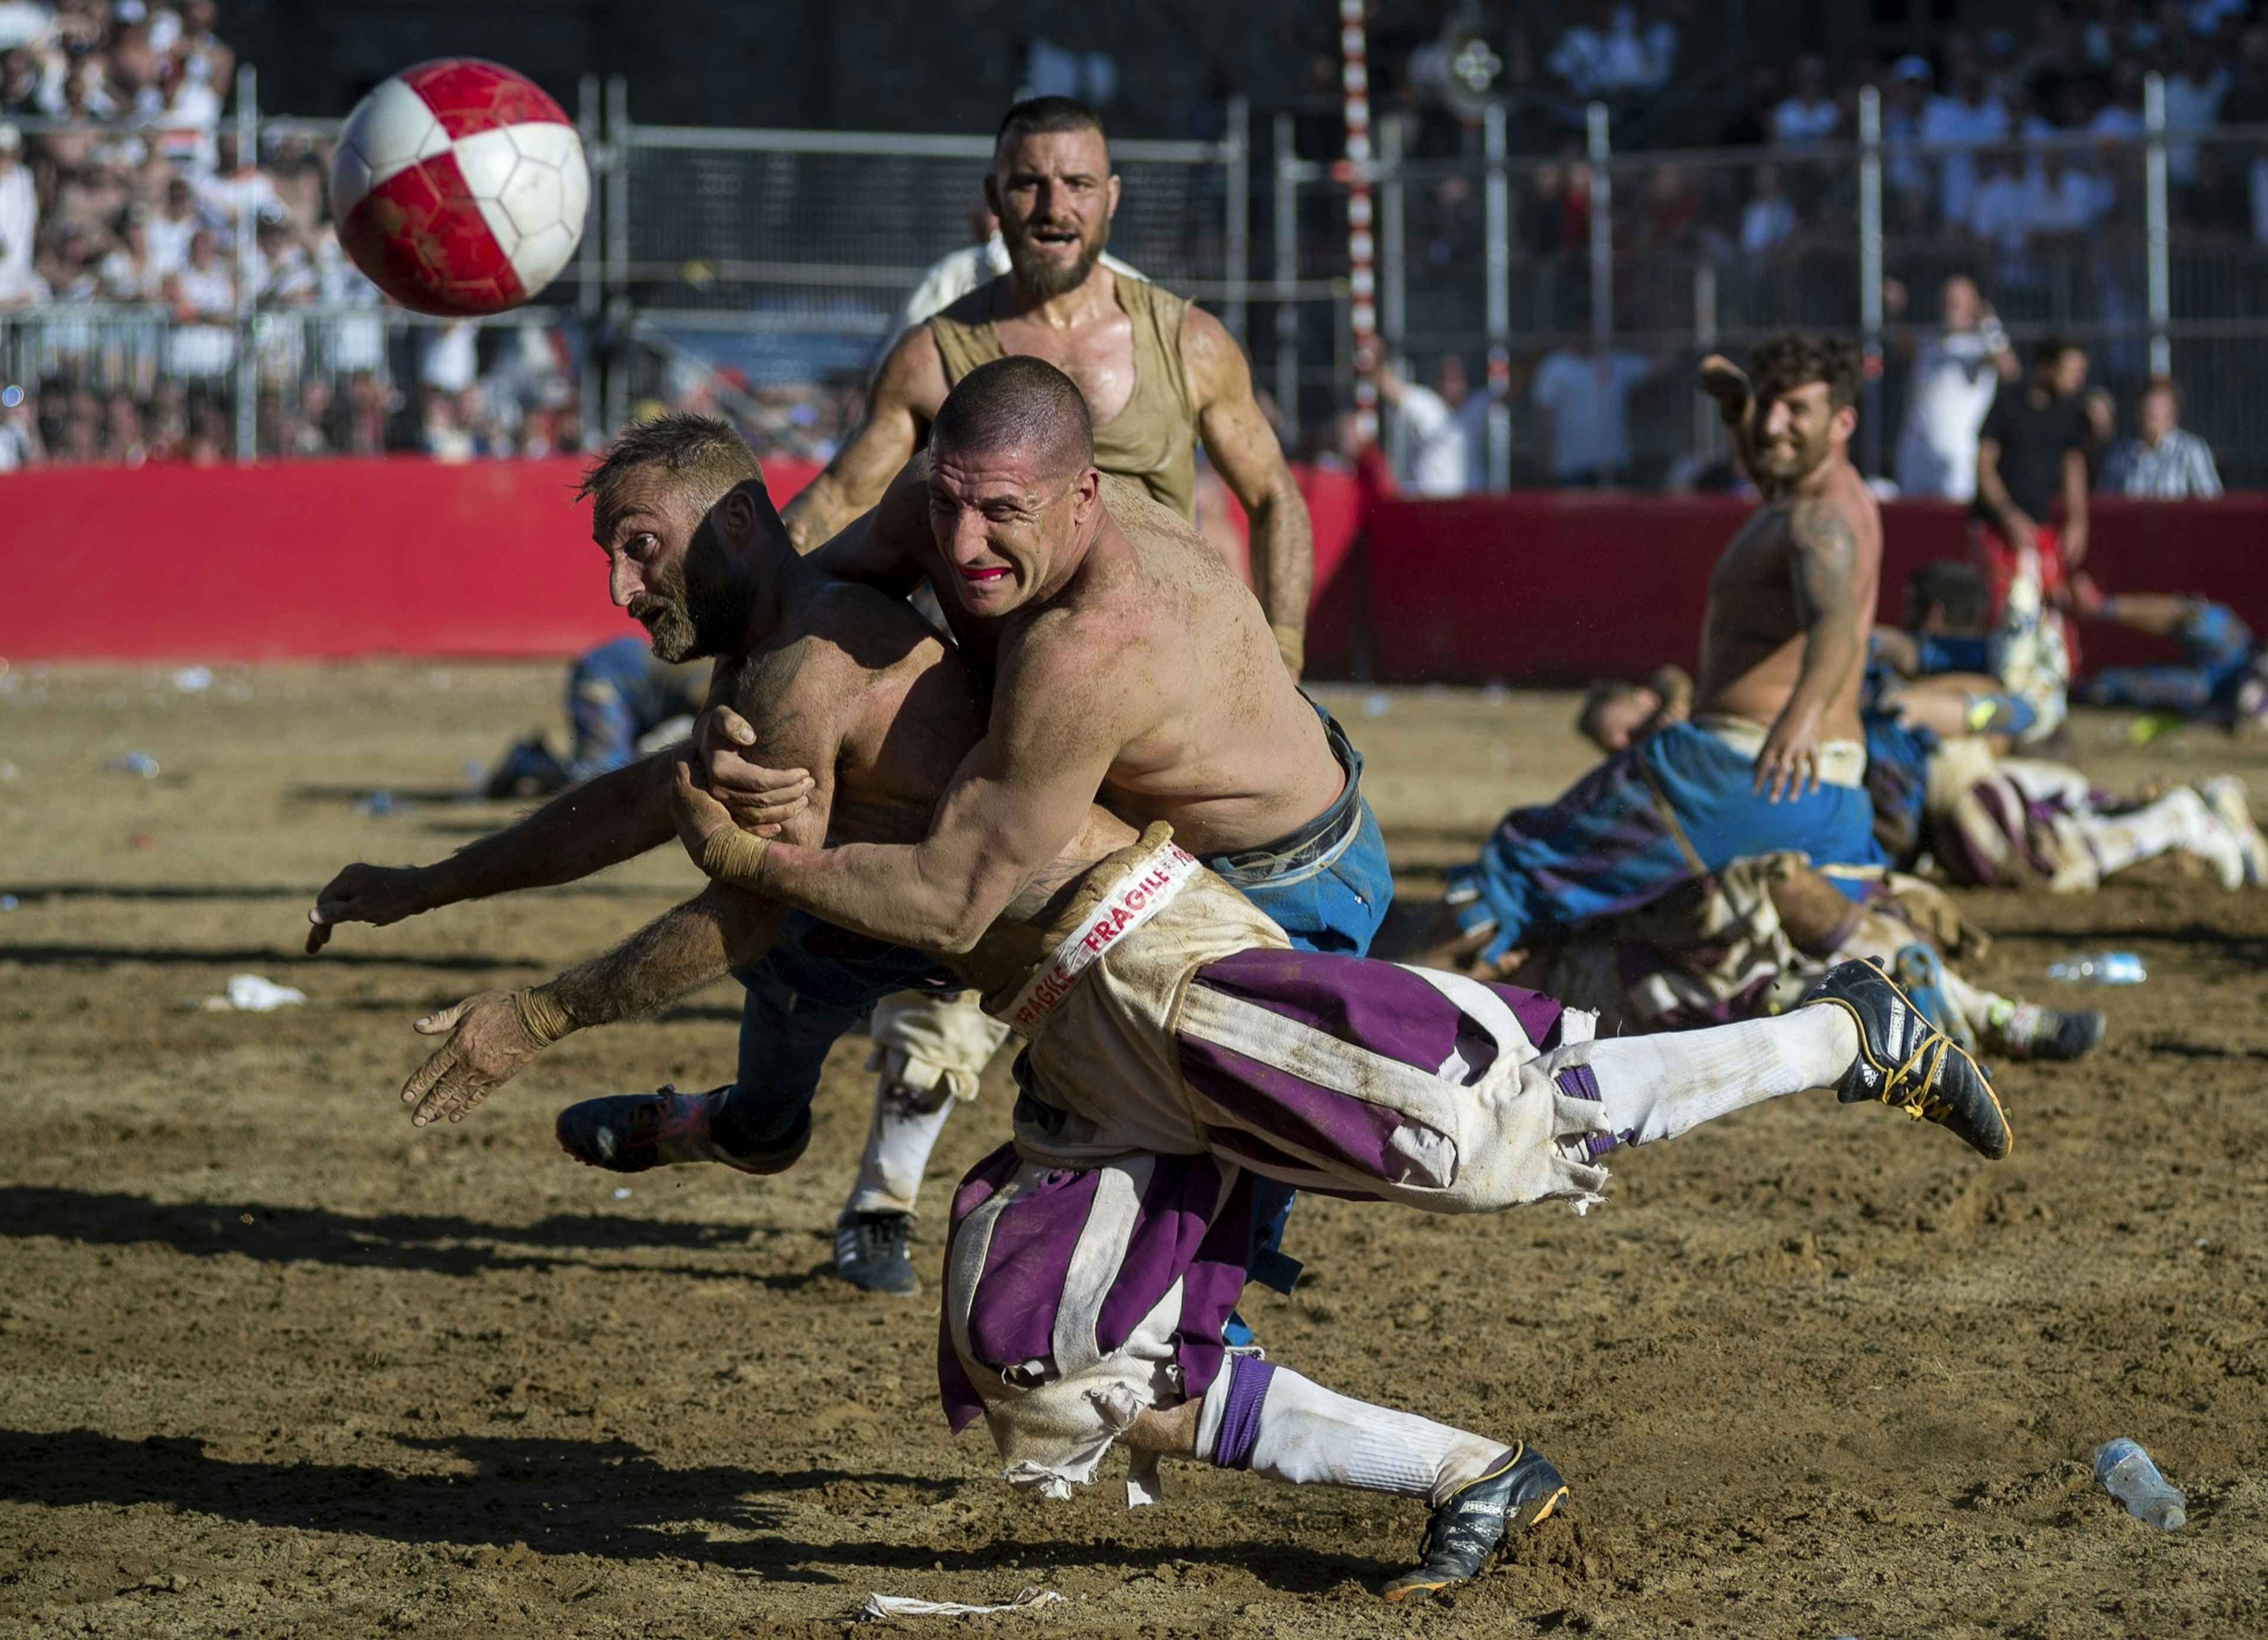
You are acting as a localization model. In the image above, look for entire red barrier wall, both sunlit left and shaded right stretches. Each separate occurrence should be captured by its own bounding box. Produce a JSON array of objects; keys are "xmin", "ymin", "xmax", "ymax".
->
[{"xmin": 0, "ymin": 458, "xmax": 2268, "ymax": 683}]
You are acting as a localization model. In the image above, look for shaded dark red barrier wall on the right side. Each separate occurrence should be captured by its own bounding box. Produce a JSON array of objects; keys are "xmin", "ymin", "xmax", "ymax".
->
[{"xmin": 1309, "ymin": 492, "xmax": 2268, "ymax": 683}]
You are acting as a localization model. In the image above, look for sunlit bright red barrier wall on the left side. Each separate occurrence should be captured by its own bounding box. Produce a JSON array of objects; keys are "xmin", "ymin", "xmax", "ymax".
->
[{"xmin": 0, "ymin": 458, "xmax": 1358, "ymax": 660}]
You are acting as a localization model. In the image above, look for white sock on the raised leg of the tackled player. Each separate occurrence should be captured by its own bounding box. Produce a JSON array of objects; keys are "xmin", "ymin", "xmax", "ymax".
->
[{"xmin": 1590, "ymin": 1007, "xmax": 1858, "ymax": 1146}]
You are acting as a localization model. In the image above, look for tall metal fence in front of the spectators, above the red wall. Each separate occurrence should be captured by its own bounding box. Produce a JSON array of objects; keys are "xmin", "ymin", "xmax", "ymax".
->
[{"xmin": 13, "ymin": 70, "xmax": 2268, "ymax": 488}]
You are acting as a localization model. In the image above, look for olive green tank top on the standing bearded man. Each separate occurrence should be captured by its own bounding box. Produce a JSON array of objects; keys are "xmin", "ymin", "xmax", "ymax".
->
[{"xmin": 930, "ymin": 275, "xmax": 1198, "ymax": 520}]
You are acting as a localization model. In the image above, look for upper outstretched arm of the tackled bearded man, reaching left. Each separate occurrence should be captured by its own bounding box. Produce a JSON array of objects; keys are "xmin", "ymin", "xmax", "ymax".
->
[{"xmin": 306, "ymin": 751, "xmax": 673, "ymax": 955}]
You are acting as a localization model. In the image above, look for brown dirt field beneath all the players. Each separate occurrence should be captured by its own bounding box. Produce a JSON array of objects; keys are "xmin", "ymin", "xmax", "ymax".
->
[{"xmin": 0, "ymin": 664, "xmax": 2268, "ymax": 1638}]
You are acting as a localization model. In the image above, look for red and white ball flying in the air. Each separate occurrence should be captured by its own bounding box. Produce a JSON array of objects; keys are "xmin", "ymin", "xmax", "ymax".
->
[{"xmin": 331, "ymin": 57, "xmax": 589, "ymax": 318}]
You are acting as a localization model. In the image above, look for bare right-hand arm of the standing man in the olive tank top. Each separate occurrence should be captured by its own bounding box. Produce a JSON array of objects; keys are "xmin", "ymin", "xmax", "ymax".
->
[{"xmin": 1182, "ymin": 308, "xmax": 1315, "ymax": 678}]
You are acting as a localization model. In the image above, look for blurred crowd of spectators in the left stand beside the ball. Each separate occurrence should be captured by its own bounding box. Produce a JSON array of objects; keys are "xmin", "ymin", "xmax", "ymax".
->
[{"xmin": 0, "ymin": 0, "xmax": 621, "ymax": 472}]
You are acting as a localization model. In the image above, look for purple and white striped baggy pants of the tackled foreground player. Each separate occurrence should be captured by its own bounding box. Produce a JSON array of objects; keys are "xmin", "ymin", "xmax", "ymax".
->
[{"xmin": 939, "ymin": 950, "xmax": 1606, "ymax": 1495}]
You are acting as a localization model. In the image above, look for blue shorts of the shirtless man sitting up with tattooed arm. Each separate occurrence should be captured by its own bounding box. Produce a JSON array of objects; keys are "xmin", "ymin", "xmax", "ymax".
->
[{"xmin": 1449, "ymin": 723, "xmax": 1885, "ymax": 960}]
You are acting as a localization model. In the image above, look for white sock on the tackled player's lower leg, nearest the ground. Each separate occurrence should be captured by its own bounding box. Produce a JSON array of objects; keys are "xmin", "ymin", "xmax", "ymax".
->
[{"xmin": 1198, "ymin": 1357, "xmax": 1508, "ymax": 1504}]
